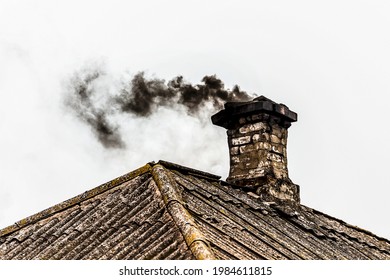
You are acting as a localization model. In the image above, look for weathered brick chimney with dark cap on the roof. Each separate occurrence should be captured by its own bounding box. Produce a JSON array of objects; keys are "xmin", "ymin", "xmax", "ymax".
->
[{"xmin": 211, "ymin": 96, "xmax": 300, "ymax": 203}]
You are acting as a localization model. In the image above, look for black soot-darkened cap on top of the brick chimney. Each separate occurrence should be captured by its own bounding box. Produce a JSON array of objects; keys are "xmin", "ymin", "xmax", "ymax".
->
[{"xmin": 211, "ymin": 95, "xmax": 298, "ymax": 128}]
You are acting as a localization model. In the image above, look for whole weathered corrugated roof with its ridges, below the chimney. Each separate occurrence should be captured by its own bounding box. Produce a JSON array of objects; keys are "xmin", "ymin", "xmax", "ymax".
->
[{"xmin": 0, "ymin": 161, "xmax": 390, "ymax": 259}]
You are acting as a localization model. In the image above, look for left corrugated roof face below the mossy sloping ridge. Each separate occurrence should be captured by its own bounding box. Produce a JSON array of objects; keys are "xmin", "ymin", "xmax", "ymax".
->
[{"xmin": 0, "ymin": 165, "xmax": 193, "ymax": 259}]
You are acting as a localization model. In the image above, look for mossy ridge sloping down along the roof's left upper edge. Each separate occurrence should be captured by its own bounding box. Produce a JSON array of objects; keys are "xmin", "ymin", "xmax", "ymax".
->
[{"xmin": 0, "ymin": 163, "xmax": 153, "ymax": 237}]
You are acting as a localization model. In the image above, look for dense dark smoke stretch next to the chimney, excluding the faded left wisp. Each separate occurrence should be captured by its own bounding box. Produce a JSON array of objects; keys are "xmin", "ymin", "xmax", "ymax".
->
[{"xmin": 116, "ymin": 72, "xmax": 251, "ymax": 117}]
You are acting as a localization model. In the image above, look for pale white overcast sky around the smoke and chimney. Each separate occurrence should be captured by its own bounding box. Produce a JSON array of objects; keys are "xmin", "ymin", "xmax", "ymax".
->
[{"xmin": 0, "ymin": 0, "xmax": 390, "ymax": 239}]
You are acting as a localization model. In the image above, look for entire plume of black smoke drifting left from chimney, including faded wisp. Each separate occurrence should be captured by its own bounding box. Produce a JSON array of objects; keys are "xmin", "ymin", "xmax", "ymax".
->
[{"xmin": 65, "ymin": 69, "xmax": 253, "ymax": 149}]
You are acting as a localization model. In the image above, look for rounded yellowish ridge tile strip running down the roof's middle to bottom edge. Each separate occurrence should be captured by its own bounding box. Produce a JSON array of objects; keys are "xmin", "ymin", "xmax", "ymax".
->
[{"xmin": 151, "ymin": 164, "xmax": 216, "ymax": 260}]
